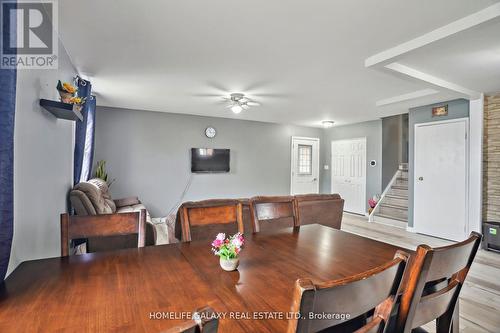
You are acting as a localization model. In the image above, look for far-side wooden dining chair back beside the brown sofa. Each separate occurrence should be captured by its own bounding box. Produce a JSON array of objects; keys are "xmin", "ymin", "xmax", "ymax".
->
[{"xmin": 250, "ymin": 196, "xmax": 300, "ymax": 232}]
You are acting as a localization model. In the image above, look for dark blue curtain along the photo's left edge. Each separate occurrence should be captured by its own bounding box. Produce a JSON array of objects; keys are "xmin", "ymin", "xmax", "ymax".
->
[{"xmin": 0, "ymin": 1, "xmax": 17, "ymax": 281}]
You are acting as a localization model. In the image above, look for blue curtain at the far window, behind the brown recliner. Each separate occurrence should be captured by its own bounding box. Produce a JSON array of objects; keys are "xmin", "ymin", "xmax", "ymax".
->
[{"xmin": 73, "ymin": 78, "xmax": 96, "ymax": 185}]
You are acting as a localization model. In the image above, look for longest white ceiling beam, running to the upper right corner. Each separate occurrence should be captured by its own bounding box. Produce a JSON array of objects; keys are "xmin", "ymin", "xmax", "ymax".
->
[{"xmin": 365, "ymin": 2, "xmax": 500, "ymax": 67}]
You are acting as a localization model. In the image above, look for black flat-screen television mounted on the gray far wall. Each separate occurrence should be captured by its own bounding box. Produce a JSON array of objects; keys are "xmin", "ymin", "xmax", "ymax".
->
[{"xmin": 191, "ymin": 148, "xmax": 230, "ymax": 173}]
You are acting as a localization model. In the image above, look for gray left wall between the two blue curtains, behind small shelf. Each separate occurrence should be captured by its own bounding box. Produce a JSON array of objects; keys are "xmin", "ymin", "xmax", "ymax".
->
[{"xmin": 8, "ymin": 39, "xmax": 75, "ymax": 274}]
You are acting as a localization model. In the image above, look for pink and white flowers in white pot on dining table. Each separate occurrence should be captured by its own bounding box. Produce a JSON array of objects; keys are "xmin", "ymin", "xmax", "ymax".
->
[{"xmin": 212, "ymin": 232, "xmax": 245, "ymax": 271}]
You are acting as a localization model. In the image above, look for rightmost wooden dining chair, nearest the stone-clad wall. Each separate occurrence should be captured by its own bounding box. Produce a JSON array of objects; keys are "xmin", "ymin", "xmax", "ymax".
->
[{"xmin": 396, "ymin": 232, "xmax": 482, "ymax": 333}]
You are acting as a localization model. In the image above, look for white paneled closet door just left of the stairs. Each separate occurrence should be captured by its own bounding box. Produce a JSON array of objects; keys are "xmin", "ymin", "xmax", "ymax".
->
[{"xmin": 332, "ymin": 138, "xmax": 366, "ymax": 215}]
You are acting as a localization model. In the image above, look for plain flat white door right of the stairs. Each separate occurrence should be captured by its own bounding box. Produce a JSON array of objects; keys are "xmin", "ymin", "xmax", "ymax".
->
[{"xmin": 413, "ymin": 119, "xmax": 468, "ymax": 241}]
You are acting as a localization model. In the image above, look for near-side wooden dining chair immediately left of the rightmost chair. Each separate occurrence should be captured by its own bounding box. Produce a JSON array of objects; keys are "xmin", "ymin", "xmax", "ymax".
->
[{"xmin": 288, "ymin": 251, "xmax": 409, "ymax": 333}]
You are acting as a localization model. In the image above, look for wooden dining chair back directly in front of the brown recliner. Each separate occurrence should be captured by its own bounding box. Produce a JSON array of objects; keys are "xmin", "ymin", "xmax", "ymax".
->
[{"xmin": 61, "ymin": 210, "xmax": 146, "ymax": 257}]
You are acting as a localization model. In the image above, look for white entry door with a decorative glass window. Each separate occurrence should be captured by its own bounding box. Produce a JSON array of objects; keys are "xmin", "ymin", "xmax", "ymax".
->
[{"xmin": 290, "ymin": 137, "xmax": 319, "ymax": 195}]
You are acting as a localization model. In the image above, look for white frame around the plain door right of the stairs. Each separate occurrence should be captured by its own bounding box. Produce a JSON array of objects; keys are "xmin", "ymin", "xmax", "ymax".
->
[{"xmin": 412, "ymin": 117, "xmax": 470, "ymax": 239}]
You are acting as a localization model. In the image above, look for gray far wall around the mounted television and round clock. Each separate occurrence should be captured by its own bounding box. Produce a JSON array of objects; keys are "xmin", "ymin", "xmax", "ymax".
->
[{"xmin": 94, "ymin": 107, "xmax": 323, "ymax": 216}]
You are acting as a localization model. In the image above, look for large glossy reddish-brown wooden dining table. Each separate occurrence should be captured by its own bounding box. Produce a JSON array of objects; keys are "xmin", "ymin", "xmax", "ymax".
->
[{"xmin": 0, "ymin": 224, "xmax": 406, "ymax": 332}]
